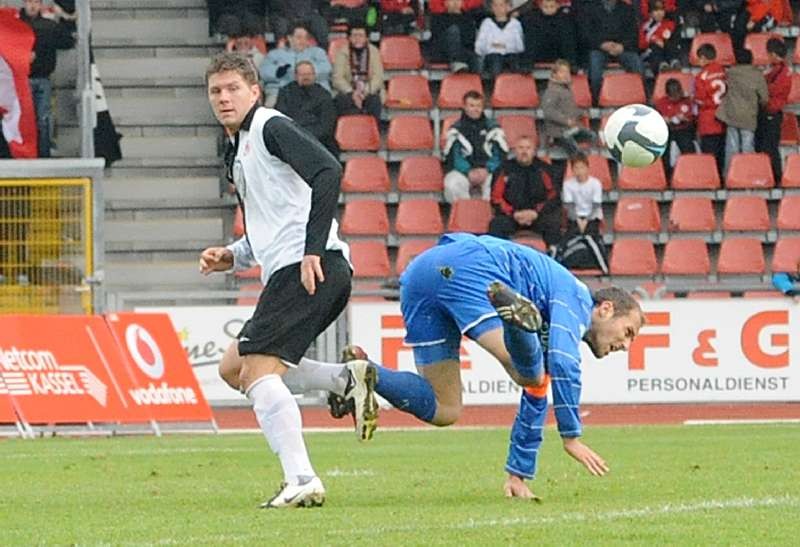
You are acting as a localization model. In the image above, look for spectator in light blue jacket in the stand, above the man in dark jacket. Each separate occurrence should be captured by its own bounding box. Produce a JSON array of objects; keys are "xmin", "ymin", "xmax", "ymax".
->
[{"xmin": 259, "ymin": 24, "xmax": 331, "ymax": 106}]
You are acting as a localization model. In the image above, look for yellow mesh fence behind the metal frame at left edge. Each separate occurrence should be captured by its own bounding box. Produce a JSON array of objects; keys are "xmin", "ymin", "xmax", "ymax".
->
[{"xmin": 0, "ymin": 178, "xmax": 93, "ymax": 313}]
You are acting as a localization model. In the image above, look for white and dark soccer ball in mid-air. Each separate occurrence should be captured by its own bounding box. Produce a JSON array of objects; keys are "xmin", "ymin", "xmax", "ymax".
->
[{"xmin": 603, "ymin": 104, "xmax": 669, "ymax": 167}]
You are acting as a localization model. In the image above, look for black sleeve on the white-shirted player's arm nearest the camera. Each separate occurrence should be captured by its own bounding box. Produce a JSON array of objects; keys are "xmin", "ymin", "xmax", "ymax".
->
[{"xmin": 263, "ymin": 116, "xmax": 342, "ymax": 256}]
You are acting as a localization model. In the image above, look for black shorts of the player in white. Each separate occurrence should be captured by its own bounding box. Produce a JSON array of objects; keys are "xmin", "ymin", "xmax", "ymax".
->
[{"xmin": 238, "ymin": 251, "xmax": 352, "ymax": 365}]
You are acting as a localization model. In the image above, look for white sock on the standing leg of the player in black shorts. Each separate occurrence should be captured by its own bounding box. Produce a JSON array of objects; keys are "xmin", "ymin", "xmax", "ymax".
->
[{"xmin": 246, "ymin": 374, "xmax": 316, "ymax": 484}]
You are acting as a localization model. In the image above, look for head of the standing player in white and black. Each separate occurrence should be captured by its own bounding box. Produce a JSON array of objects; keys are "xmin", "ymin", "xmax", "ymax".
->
[{"xmin": 206, "ymin": 52, "xmax": 261, "ymax": 134}]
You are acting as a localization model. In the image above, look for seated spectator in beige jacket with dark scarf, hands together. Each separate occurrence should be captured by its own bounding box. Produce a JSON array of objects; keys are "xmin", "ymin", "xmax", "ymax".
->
[{"xmin": 333, "ymin": 23, "xmax": 386, "ymax": 121}]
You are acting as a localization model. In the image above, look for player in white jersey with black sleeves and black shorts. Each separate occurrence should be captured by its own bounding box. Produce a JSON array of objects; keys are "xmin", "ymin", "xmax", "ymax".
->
[{"xmin": 200, "ymin": 53, "xmax": 377, "ymax": 508}]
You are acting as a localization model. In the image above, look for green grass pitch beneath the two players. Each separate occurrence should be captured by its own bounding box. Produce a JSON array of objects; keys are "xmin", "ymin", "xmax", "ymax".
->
[{"xmin": 0, "ymin": 425, "xmax": 800, "ymax": 546}]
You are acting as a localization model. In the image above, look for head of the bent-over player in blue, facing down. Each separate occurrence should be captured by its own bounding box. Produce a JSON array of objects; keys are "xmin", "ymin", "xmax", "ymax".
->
[{"xmin": 584, "ymin": 287, "xmax": 644, "ymax": 358}]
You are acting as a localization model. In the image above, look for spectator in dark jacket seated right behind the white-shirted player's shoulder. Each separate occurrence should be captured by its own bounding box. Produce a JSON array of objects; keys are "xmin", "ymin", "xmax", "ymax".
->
[{"xmin": 275, "ymin": 61, "xmax": 339, "ymax": 157}]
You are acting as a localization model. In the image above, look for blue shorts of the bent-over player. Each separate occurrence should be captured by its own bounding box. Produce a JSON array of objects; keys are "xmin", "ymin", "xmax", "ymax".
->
[{"xmin": 400, "ymin": 238, "xmax": 512, "ymax": 365}]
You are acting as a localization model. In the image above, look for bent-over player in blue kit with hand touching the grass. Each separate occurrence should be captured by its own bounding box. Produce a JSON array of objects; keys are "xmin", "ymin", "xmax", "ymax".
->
[{"xmin": 332, "ymin": 234, "xmax": 644, "ymax": 497}]
